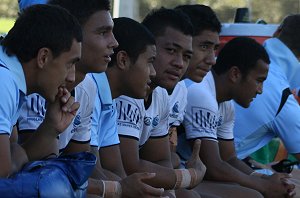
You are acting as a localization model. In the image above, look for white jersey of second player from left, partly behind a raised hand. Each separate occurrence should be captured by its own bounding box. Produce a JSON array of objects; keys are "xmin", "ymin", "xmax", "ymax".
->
[{"xmin": 18, "ymin": 75, "xmax": 96, "ymax": 150}]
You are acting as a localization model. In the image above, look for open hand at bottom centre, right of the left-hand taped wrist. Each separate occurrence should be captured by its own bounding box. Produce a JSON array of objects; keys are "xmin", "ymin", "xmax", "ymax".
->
[{"xmin": 120, "ymin": 173, "xmax": 164, "ymax": 198}]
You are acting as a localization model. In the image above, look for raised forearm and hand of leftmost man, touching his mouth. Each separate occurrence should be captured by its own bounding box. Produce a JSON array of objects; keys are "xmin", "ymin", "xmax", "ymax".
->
[{"xmin": 22, "ymin": 88, "xmax": 79, "ymax": 161}]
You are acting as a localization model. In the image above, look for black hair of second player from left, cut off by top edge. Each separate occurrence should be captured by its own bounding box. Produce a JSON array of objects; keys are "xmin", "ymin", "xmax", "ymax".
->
[{"xmin": 48, "ymin": 0, "xmax": 110, "ymax": 26}]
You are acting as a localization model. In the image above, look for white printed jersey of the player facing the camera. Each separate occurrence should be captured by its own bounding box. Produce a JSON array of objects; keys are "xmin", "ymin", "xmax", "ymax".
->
[{"xmin": 116, "ymin": 88, "xmax": 170, "ymax": 146}]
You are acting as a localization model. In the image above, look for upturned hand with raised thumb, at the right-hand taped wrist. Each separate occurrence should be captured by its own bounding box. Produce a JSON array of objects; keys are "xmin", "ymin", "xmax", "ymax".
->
[{"xmin": 186, "ymin": 139, "xmax": 206, "ymax": 188}]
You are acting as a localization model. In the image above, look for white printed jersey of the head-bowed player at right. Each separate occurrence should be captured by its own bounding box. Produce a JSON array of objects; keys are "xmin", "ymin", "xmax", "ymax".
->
[{"xmin": 177, "ymin": 72, "xmax": 234, "ymax": 159}]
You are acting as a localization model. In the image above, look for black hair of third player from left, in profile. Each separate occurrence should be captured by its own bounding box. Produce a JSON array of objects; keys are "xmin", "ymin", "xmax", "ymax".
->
[{"xmin": 108, "ymin": 17, "xmax": 155, "ymax": 66}]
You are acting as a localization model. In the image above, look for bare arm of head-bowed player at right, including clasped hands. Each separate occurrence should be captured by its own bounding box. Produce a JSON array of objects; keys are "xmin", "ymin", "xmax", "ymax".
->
[{"xmin": 200, "ymin": 140, "xmax": 288, "ymax": 197}]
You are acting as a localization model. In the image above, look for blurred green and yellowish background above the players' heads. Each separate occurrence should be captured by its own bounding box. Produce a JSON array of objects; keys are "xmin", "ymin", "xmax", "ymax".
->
[{"xmin": 0, "ymin": 0, "xmax": 300, "ymax": 33}]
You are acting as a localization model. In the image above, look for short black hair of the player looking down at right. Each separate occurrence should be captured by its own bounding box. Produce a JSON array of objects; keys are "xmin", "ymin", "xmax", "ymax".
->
[{"xmin": 212, "ymin": 37, "xmax": 270, "ymax": 77}]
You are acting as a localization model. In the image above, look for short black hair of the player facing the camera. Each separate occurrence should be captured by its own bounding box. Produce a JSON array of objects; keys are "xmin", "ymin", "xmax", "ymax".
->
[{"xmin": 142, "ymin": 7, "xmax": 193, "ymax": 37}]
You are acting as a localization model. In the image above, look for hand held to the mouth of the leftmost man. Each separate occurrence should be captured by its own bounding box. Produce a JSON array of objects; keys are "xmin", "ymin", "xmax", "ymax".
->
[{"xmin": 44, "ymin": 87, "xmax": 80, "ymax": 135}]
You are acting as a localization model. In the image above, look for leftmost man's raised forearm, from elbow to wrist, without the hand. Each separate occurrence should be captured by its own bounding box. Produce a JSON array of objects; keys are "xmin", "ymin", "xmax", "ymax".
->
[{"xmin": 22, "ymin": 122, "xmax": 59, "ymax": 161}]
